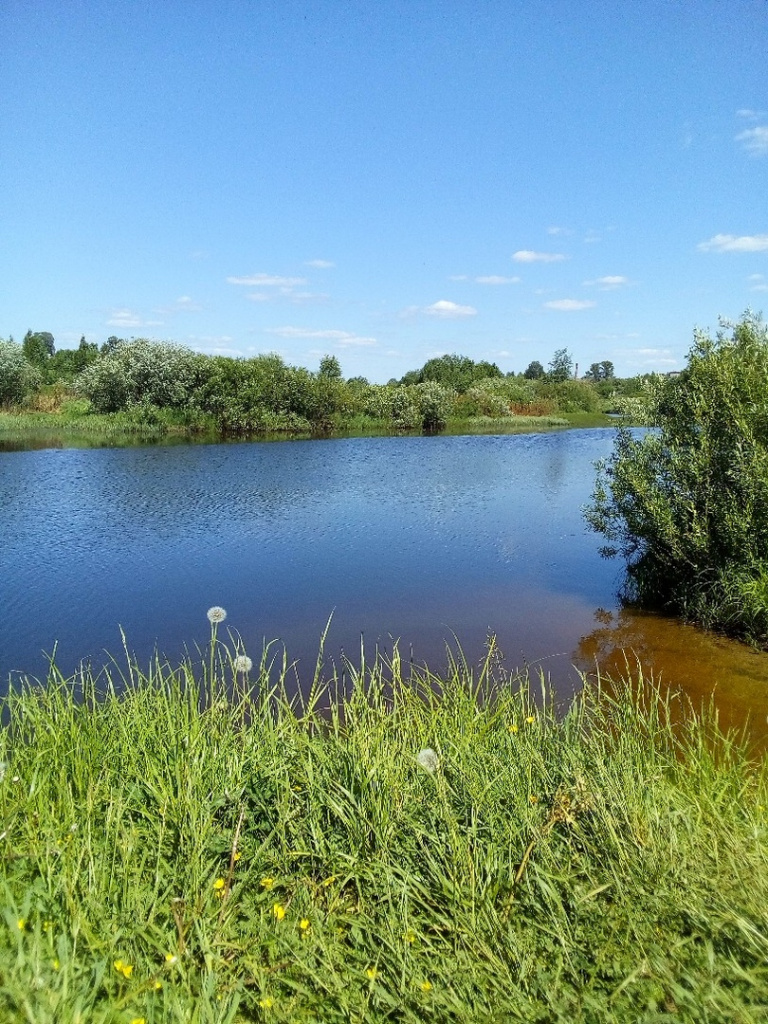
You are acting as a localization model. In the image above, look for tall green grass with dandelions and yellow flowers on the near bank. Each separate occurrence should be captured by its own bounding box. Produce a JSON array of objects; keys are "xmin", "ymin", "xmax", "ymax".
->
[{"xmin": 0, "ymin": 644, "xmax": 768, "ymax": 1024}]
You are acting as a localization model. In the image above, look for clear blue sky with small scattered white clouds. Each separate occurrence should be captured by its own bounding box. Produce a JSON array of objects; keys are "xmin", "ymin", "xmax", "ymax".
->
[{"xmin": 0, "ymin": 0, "xmax": 768, "ymax": 381}]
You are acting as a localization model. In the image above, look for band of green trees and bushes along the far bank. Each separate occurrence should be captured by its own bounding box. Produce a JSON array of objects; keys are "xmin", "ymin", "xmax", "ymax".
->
[{"xmin": 0, "ymin": 332, "xmax": 642, "ymax": 435}]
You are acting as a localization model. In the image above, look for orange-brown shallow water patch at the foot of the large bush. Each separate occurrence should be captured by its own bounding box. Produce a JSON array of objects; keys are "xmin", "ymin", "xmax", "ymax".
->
[{"xmin": 572, "ymin": 608, "xmax": 768, "ymax": 737}]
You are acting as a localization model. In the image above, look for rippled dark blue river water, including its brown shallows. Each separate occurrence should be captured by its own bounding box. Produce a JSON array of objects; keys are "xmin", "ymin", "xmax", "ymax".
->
[{"xmin": 0, "ymin": 429, "xmax": 768, "ymax": 732}]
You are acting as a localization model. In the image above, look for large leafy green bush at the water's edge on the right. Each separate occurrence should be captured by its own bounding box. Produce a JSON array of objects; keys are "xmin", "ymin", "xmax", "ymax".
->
[{"xmin": 586, "ymin": 311, "xmax": 768, "ymax": 646}]
